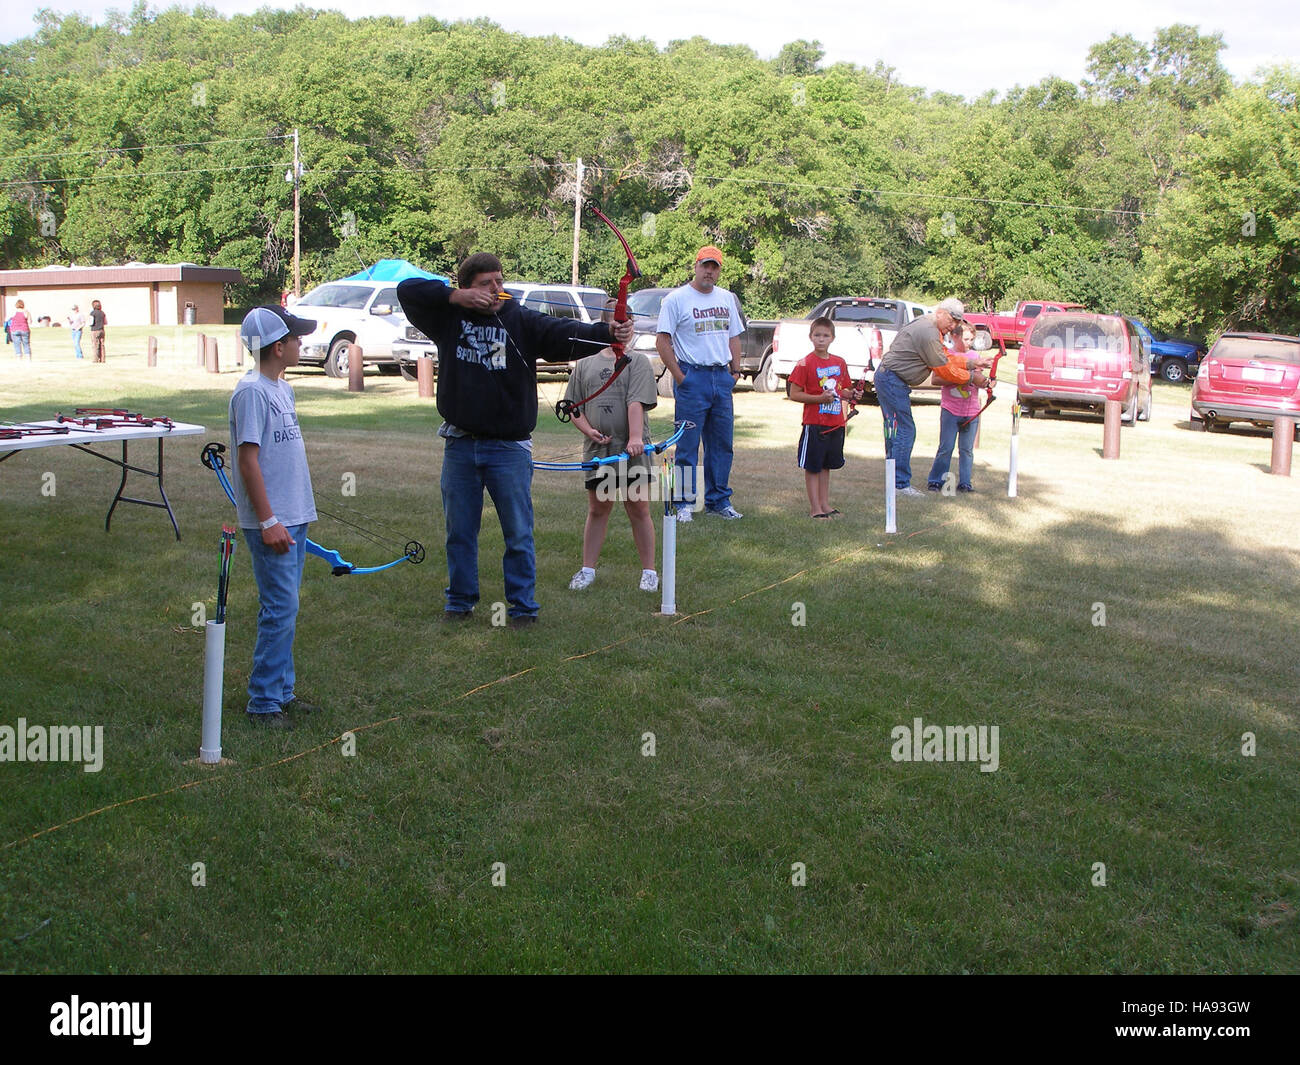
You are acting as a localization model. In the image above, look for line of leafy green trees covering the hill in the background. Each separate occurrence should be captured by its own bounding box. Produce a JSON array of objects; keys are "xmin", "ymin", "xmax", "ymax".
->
[{"xmin": 0, "ymin": 3, "xmax": 1300, "ymax": 334}]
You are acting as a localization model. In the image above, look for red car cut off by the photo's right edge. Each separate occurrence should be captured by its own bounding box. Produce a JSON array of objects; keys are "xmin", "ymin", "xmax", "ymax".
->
[{"xmin": 1192, "ymin": 333, "xmax": 1300, "ymax": 440}]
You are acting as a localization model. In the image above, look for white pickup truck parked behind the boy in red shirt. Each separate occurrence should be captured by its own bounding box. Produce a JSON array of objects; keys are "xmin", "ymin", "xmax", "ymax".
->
[{"xmin": 754, "ymin": 296, "xmax": 930, "ymax": 391}]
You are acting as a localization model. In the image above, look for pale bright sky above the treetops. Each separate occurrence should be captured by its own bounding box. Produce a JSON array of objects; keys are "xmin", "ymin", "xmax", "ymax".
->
[{"xmin": 0, "ymin": 0, "xmax": 1300, "ymax": 98}]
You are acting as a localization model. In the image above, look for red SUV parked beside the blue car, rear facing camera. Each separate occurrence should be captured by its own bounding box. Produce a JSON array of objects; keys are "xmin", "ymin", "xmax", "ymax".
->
[{"xmin": 1015, "ymin": 311, "xmax": 1151, "ymax": 424}]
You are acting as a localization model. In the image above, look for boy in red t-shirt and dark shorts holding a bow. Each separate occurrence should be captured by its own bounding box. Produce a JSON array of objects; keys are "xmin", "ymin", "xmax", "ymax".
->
[{"xmin": 788, "ymin": 319, "xmax": 862, "ymax": 521}]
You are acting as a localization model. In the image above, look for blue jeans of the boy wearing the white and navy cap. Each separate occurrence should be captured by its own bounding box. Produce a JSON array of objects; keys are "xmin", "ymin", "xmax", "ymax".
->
[{"xmin": 242, "ymin": 525, "xmax": 308, "ymax": 714}]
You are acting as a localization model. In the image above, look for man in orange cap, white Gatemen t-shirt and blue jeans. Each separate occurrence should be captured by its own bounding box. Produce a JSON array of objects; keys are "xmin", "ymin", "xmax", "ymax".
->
[{"xmin": 655, "ymin": 244, "xmax": 745, "ymax": 521}]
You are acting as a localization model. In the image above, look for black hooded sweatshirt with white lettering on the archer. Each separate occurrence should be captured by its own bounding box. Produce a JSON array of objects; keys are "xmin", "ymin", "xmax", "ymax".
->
[{"xmin": 398, "ymin": 277, "xmax": 614, "ymax": 440}]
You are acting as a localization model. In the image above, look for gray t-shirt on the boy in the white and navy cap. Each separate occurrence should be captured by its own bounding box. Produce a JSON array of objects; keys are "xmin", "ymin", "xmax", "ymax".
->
[{"xmin": 230, "ymin": 369, "xmax": 316, "ymax": 529}]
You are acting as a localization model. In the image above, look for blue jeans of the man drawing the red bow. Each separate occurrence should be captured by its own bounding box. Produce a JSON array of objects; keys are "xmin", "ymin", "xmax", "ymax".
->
[{"xmin": 442, "ymin": 437, "xmax": 538, "ymax": 618}]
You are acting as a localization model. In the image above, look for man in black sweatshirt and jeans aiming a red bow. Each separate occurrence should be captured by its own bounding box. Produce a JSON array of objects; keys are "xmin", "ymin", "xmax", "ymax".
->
[{"xmin": 398, "ymin": 252, "xmax": 633, "ymax": 628}]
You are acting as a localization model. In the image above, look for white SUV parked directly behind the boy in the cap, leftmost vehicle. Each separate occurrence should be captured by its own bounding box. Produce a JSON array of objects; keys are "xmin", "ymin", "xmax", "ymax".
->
[{"xmin": 291, "ymin": 280, "xmax": 407, "ymax": 377}]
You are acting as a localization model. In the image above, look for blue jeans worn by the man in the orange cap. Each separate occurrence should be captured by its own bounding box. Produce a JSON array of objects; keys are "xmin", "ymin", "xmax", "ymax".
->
[{"xmin": 672, "ymin": 365, "xmax": 736, "ymax": 510}]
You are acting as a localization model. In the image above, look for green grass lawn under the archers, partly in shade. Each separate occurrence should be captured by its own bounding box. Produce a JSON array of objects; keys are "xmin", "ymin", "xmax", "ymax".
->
[{"xmin": 0, "ymin": 351, "xmax": 1300, "ymax": 973}]
